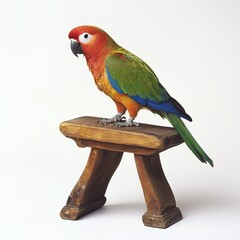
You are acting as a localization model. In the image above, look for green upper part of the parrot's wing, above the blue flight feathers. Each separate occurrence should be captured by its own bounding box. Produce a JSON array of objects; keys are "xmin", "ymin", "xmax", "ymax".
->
[{"xmin": 106, "ymin": 51, "xmax": 169, "ymax": 103}]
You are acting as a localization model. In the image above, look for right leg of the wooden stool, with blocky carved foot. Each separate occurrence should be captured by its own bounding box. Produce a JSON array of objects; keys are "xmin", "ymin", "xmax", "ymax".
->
[{"xmin": 135, "ymin": 153, "xmax": 182, "ymax": 228}]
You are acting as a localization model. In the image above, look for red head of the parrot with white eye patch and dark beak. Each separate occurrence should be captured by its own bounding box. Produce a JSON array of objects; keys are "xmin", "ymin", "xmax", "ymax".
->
[{"xmin": 68, "ymin": 26, "xmax": 118, "ymax": 59}]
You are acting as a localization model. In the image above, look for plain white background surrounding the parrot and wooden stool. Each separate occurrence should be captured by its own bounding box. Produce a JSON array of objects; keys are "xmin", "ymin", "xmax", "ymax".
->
[{"xmin": 0, "ymin": 0, "xmax": 240, "ymax": 240}]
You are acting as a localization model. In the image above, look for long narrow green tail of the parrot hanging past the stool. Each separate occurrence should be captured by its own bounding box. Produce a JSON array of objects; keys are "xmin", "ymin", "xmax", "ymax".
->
[{"xmin": 164, "ymin": 113, "xmax": 213, "ymax": 167}]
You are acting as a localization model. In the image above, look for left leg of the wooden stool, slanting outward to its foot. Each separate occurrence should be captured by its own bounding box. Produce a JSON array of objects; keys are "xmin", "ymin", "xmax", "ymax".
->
[{"xmin": 60, "ymin": 148, "xmax": 123, "ymax": 220}]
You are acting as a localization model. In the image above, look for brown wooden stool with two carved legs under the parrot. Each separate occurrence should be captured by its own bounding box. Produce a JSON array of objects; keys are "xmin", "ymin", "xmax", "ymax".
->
[{"xmin": 60, "ymin": 117, "xmax": 183, "ymax": 228}]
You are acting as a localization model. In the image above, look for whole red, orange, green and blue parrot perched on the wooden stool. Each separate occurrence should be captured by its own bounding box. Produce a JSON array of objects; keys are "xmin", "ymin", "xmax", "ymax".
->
[{"xmin": 68, "ymin": 25, "xmax": 214, "ymax": 167}]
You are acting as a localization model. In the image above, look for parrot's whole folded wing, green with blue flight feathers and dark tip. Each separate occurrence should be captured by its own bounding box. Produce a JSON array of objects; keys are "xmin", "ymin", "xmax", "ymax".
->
[{"xmin": 106, "ymin": 50, "xmax": 192, "ymax": 121}]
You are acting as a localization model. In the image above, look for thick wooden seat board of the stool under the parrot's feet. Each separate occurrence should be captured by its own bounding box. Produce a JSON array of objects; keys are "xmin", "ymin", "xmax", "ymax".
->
[{"xmin": 60, "ymin": 117, "xmax": 183, "ymax": 152}]
